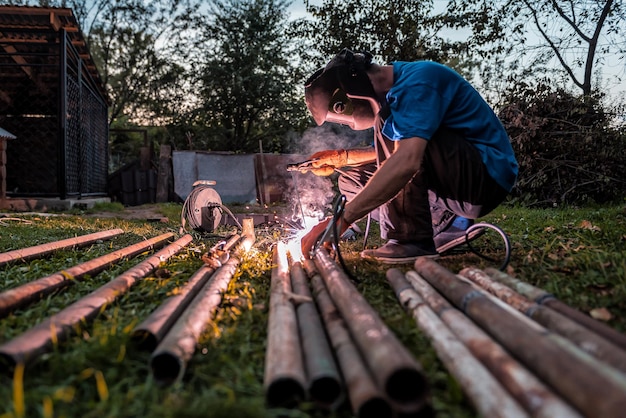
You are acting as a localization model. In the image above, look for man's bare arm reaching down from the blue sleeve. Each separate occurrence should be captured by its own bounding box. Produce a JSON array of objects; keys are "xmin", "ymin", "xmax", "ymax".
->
[{"xmin": 343, "ymin": 137, "xmax": 428, "ymax": 225}]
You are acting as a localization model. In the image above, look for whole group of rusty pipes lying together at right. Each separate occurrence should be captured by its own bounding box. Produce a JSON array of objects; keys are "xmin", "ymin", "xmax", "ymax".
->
[{"xmin": 387, "ymin": 259, "xmax": 626, "ymax": 417}]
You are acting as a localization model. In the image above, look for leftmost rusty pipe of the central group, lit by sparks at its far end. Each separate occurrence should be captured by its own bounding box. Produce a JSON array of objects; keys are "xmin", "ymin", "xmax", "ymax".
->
[{"xmin": 263, "ymin": 241, "xmax": 306, "ymax": 406}]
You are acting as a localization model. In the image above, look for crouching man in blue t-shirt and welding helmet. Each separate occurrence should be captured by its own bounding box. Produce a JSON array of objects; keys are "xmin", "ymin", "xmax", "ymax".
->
[{"xmin": 302, "ymin": 49, "xmax": 518, "ymax": 263}]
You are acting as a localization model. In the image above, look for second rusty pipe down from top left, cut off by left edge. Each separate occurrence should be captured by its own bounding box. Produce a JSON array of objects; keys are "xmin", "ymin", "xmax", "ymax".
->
[{"xmin": 0, "ymin": 232, "xmax": 174, "ymax": 318}]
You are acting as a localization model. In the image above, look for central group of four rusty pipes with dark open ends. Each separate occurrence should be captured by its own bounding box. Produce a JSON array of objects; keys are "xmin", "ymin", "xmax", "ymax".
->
[{"xmin": 264, "ymin": 243, "xmax": 432, "ymax": 418}]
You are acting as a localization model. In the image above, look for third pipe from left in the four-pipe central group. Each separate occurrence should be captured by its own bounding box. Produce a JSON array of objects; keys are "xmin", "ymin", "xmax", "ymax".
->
[{"xmin": 304, "ymin": 260, "xmax": 393, "ymax": 418}]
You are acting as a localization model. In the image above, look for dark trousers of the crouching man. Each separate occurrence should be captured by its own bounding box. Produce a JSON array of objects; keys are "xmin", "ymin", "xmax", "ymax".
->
[{"xmin": 338, "ymin": 129, "xmax": 508, "ymax": 242}]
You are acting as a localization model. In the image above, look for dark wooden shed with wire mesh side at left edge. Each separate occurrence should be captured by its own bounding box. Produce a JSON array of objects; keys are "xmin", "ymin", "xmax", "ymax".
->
[{"xmin": 0, "ymin": 6, "xmax": 108, "ymax": 199}]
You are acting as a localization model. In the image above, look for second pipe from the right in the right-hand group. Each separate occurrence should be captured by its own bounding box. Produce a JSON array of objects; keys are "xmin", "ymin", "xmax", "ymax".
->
[{"xmin": 460, "ymin": 268, "xmax": 626, "ymax": 373}]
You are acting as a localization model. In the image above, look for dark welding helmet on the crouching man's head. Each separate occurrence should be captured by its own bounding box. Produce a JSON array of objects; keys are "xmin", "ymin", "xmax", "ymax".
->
[{"xmin": 304, "ymin": 49, "xmax": 379, "ymax": 130}]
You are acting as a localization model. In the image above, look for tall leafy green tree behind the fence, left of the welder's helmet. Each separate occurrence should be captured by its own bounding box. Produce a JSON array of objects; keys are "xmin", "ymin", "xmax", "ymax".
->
[{"xmin": 195, "ymin": 0, "xmax": 306, "ymax": 152}]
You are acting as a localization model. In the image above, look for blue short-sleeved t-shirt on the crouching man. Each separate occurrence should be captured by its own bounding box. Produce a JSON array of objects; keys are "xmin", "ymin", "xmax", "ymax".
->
[{"xmin": 382, "ymin": 61, "xmax": 518, "ymax": 191}]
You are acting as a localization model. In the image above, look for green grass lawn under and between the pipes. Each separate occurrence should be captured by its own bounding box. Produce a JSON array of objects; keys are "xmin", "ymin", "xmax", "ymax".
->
[{"xmin": 0, "ymin": 204, "xmax": 626, "ymax": 418}]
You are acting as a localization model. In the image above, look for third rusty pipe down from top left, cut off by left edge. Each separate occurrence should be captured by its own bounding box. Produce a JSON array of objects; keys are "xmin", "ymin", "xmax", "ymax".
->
[{"xmin": 0, "ymin": 235, "xmax": 193, "ymax": 368}]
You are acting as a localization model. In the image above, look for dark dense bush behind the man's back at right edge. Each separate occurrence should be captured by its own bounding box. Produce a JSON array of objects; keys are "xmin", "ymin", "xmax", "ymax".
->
[{"xmin": 499, "ymin": 85, "xmax": 626, "ymax": 206}]
